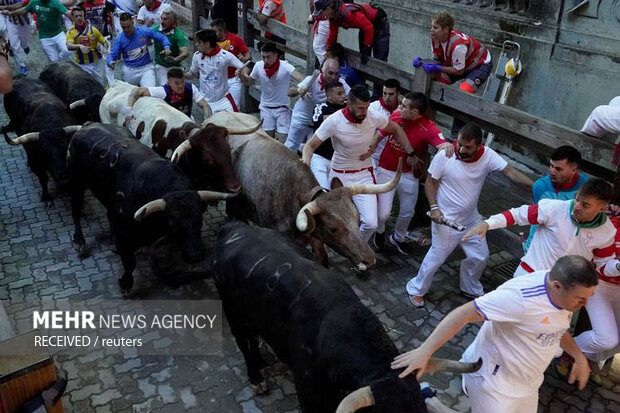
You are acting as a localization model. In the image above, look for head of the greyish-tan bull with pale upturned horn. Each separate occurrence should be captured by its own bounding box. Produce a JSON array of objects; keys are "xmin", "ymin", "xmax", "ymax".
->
[{"xmin": 295, "ymin": 158, "xmax": 401, "ymax": 266}]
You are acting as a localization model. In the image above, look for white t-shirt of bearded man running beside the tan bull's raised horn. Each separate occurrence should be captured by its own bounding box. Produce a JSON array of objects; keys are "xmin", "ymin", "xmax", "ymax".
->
[{"xmin": 315, "ymin": 109, "xmax": 389, "ymax": 170}]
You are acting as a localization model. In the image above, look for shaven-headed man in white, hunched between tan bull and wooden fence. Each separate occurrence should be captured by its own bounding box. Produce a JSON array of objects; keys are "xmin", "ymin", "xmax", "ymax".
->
[{"xmin": 284, "ymin": 59, "xmax": 350, "ymax": 152}]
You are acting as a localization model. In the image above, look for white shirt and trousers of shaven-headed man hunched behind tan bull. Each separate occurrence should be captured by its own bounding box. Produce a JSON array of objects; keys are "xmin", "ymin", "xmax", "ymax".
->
[{"xmin": 284, "ymin": 73, "xmax": 348, "ymax": 152}]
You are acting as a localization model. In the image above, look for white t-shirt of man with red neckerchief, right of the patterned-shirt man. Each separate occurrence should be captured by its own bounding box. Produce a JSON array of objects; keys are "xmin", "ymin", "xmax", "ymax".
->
[{"xmin": 250, "ymin": 60, "xmax": 295, "ymax": 109}]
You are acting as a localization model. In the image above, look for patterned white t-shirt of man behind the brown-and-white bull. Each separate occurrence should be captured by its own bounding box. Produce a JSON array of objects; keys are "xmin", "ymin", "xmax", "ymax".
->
[{"xmin": 189, "ymin": 50, "xmax": 243, "ymax": 102}]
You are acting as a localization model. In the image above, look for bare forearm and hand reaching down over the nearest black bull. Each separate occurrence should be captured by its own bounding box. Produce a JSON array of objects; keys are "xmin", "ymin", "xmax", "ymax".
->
[{"xmin": 392, "ymin": 301, "xmax": 484, "ymax": 380}]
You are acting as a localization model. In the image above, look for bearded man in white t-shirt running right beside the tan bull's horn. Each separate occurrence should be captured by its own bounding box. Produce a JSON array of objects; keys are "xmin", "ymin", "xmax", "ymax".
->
[{"xmin": 302, "ymin": 85, "xmax": 417, "ymax": 241}]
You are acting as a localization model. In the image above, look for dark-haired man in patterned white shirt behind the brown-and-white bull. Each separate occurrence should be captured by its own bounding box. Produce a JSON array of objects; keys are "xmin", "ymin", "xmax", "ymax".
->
[{"xmin": 185, "ymin": 29, "xmax": 243, "ymax": 113}]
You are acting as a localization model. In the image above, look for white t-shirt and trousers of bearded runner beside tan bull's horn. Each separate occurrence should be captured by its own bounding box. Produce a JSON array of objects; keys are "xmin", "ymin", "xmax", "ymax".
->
[{"xmin": 315, "ymin": 107, "xmax": 389, "ymax": 242}]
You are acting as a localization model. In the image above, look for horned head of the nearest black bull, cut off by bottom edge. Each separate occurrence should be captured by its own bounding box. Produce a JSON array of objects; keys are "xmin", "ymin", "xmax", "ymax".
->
[{"xmin": 336, "ymin": 359, "xmax": 482, "ymax": 413}]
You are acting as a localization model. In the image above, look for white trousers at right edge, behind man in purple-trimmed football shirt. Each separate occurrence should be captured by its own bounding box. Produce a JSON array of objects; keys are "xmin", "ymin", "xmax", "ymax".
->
[{"xmin": 575, "ymin": 280, "xmax": 620, "ymax": 361}]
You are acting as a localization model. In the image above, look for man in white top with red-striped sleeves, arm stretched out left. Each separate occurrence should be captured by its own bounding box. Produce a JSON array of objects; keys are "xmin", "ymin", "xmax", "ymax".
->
[{"xmin": 463, "ymin": 178, "xmax": 616, "ymax": 277}]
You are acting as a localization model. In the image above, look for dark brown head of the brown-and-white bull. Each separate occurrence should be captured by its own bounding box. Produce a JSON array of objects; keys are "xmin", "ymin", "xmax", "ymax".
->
[{"xmin": 172, "ymin": 119, "xmax": 262, "ymax": 192}]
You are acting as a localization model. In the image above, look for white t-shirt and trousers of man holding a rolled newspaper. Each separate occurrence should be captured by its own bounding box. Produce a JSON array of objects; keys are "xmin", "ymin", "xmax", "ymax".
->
[{"xmin": 407, "ymin": 146, "xmax": 508, "ymax": 297}]
